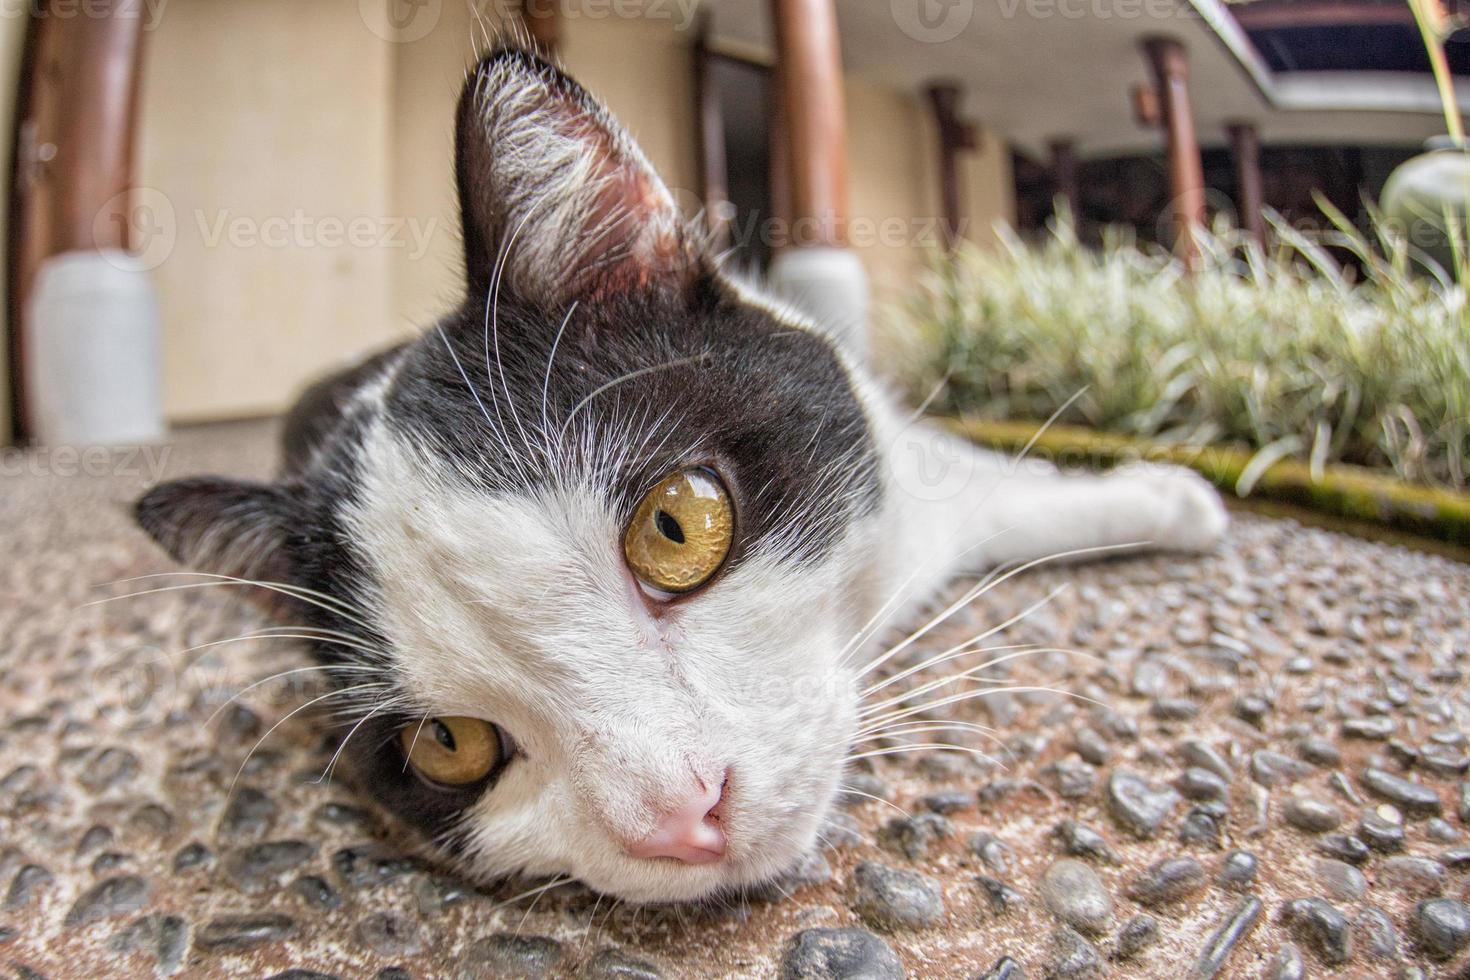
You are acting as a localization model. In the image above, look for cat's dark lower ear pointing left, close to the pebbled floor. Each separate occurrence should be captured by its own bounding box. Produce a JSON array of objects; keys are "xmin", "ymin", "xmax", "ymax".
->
[{"xmin": 132, "ymin": 476, "xmax": 303, "ymax": 593}]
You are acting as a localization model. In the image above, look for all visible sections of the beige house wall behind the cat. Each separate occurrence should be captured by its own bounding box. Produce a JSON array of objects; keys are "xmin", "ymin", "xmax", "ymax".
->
[{"xmin": 140, "ymin": 0, "xmax": 1011, "ymax": 420}]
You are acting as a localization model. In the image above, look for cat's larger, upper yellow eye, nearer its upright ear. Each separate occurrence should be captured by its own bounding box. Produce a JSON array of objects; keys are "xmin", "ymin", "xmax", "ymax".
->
[{"xmin": 623, "ymin": 469, "xmax": 735, "ymax": 594}]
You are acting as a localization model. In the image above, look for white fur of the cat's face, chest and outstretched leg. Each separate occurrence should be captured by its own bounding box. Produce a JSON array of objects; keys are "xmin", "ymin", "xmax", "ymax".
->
[{"xmin": 338, "ymin": 321, "xmax": 1225, "ymax": 901}]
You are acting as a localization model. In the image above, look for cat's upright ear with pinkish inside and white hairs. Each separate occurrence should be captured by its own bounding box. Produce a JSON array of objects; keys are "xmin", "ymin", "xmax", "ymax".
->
[{"xmin": 454, "ymin": 48, "xmax": 700, "ymax": 310}]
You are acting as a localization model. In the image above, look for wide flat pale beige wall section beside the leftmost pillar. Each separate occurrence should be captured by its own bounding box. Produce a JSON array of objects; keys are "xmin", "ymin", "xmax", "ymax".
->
[{"xmin": 138, "ymin": 0, "xmax": 394, "ymax": 420}]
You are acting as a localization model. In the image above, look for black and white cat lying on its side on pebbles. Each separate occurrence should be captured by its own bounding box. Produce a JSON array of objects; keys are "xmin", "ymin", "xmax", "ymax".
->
[{"xmin": 137, "ymin": 48, "xmax": 1226, "ymax": 901}]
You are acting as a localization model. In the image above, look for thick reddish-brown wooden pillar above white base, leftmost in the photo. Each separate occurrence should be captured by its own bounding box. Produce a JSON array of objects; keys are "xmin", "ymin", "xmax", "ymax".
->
[{"xmin": 6, "ymin": 0, "xmax": 144, "ymax": 439}]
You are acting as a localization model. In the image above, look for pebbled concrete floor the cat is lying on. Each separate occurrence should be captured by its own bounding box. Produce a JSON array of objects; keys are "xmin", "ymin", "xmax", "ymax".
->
[{"xmin": 0, "ymin": 423, "xmax": 1470, "ymax": 980}]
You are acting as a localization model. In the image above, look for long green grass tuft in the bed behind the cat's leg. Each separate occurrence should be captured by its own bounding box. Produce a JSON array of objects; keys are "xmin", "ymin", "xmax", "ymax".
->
[{"xmin": 895, "ymin": 211, "xmax": 1470, "ymax": 491}]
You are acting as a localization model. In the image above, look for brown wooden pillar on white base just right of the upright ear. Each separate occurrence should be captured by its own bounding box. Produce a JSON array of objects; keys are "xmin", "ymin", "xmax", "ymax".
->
[{"xmin": 770, "ymin": 0, "xmax": 847, "ymax": 247}]
